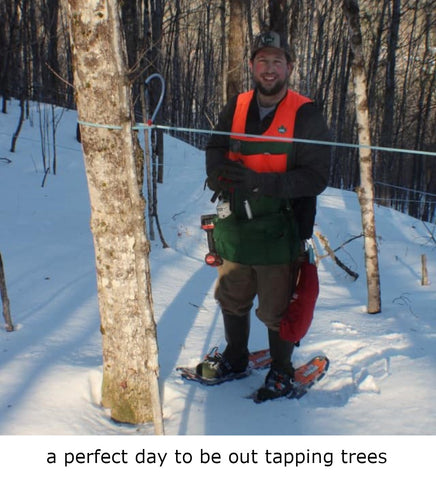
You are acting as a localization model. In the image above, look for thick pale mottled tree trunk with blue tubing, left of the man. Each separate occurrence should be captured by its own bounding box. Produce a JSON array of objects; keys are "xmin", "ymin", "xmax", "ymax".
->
[{"xmin": 69, "ymin": 0, "xmax": 163, "ymax": 433}]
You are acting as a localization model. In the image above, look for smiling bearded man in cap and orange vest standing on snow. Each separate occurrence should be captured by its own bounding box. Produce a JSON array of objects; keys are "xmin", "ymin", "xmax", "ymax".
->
[{"xmin": 197, "ymin": 32, "xmax": 330, "ymax": 398}]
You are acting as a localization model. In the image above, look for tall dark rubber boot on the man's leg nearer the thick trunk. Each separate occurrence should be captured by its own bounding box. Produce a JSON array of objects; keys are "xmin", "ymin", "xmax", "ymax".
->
[{"xmin": 223, "ymin": 313, "xmax": 250, "ymax": 372}]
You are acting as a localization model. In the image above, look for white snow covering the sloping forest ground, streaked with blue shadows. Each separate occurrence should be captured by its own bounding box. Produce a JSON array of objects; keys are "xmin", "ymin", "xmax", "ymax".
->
[{"xmin": 0, "ymin": 101, "xmax": 436, "ymax": 478}]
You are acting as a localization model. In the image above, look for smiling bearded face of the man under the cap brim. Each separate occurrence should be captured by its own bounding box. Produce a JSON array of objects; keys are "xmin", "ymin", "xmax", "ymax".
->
[{"xmin": 251, "ymin": 48, "xmax": 292, "ymax": 96}]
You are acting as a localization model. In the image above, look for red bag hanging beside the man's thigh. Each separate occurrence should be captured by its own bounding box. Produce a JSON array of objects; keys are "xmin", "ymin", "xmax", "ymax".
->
[{"xmin": 280, "ymin": 257, "xmax": 319, "ymax": 343}]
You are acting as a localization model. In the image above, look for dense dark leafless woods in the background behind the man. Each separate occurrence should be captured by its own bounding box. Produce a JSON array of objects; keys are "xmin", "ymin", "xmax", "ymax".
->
[{"xmin": 0, "ymin": 0, "xmax": 436, "ymax": 221}]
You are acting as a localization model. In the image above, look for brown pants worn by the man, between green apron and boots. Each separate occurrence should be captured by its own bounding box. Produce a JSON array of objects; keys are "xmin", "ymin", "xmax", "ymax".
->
[{"xmin": 215, "ymin": 260, "xmax": 298, "ymax": 331}]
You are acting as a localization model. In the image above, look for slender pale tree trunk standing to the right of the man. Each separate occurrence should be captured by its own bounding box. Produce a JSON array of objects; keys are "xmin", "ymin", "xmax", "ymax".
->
[{"xmin": 343, "ymin": 0, "xmax": 381, "ymax": 313}]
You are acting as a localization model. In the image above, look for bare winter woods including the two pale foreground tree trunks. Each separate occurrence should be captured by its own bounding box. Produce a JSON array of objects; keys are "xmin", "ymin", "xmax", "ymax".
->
[{"xmin": 0, "ymin": 0, "xmax": 436, "ymax": 431}]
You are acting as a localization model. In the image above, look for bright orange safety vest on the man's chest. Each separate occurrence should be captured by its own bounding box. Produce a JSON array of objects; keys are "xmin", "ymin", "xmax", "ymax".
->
[{"xmin": 228, "ymin": 90, "xmax": 312, "ymax": 173}]
